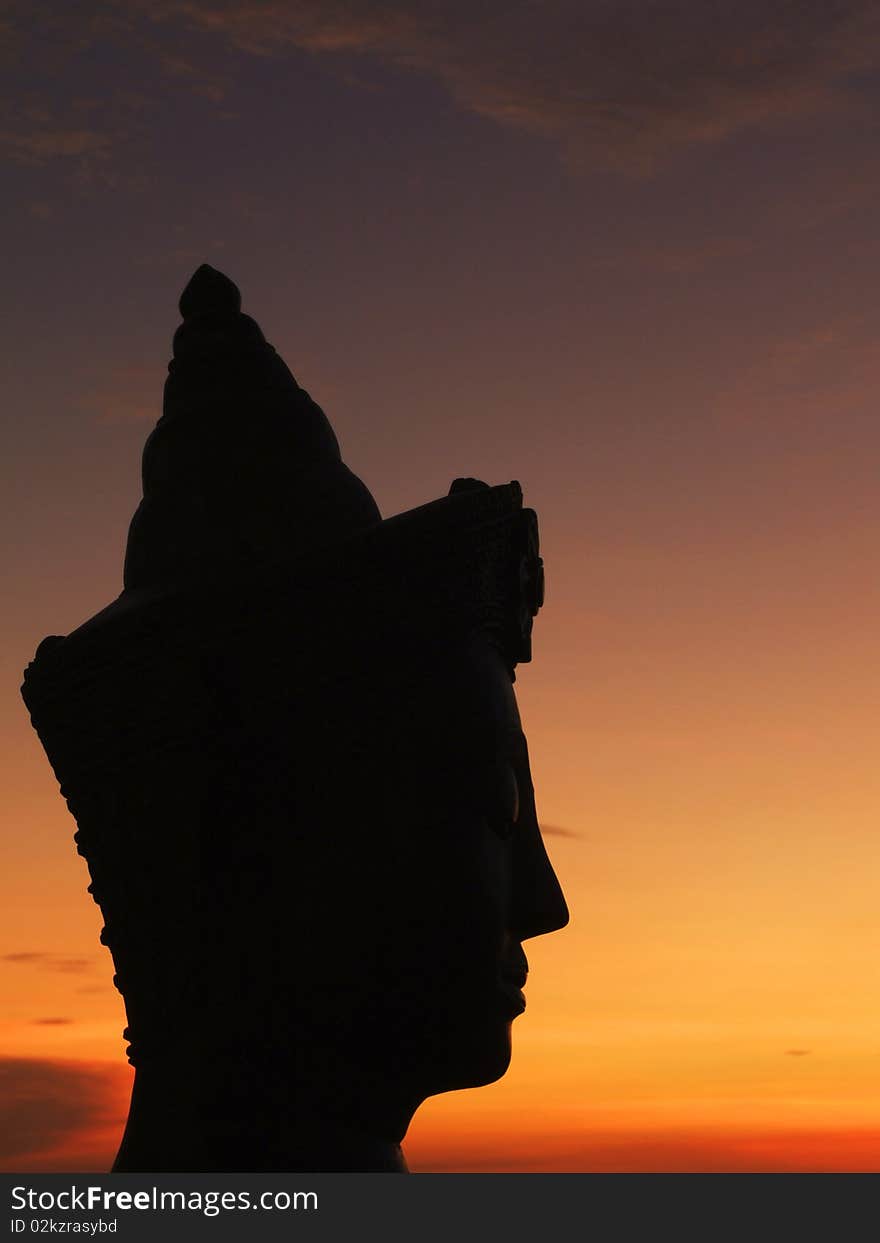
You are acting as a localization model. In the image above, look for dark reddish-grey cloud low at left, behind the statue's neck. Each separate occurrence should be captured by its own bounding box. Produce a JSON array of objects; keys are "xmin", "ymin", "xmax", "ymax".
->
[{"xmin": 0, "ymin": 1058, "xmax": 124, "ymax": 1171}]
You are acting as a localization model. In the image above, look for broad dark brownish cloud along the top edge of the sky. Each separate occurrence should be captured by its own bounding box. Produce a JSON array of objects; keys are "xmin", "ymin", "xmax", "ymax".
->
[{"xmin": 150, "ymin": 0, "xmax": 880, "ymax": 170}]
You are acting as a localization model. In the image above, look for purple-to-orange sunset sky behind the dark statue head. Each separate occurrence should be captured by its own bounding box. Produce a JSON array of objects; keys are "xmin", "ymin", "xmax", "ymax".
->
[{"xmin": 0, "ymin": 0, "xmax": 880, "ymax": 1171}]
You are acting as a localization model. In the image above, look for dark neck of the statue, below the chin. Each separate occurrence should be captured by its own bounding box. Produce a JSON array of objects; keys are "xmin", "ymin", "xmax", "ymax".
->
[{"xmin": 113, "ymin": 1065, "xmax": 418, "ymax": 1173}]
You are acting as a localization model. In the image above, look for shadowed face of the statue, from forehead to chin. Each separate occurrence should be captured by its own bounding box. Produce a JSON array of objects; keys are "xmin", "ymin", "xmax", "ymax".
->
[{"xmin": 285, "ymin": 639, "xmax": 568, "ymax": 1101}]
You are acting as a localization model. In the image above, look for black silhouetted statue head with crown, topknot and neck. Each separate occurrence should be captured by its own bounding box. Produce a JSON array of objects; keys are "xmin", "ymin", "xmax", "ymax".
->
[{"xmin": 22, "ymin": 266, "xmax": 568, "ymax": 1172}]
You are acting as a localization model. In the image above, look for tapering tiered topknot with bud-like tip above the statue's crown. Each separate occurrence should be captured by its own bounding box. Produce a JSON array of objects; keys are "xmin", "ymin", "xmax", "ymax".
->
[{"xmin": 123, "ymin": 264, "xmax": 382, "ymax": 590}]
